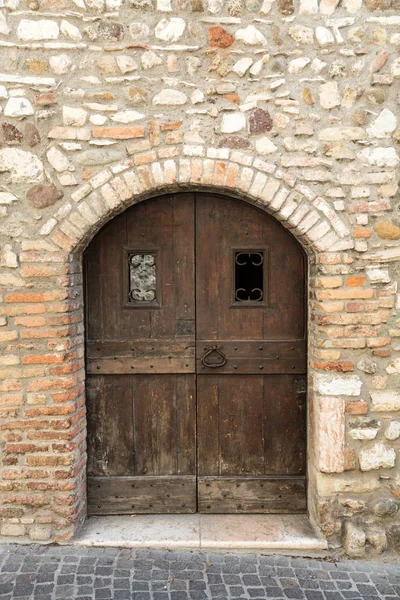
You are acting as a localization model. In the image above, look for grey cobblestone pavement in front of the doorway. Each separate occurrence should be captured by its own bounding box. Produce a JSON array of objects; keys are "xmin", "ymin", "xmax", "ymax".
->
[{"xmin": 0, "ymin": 545, "xmax": 400, "ymax": 600}]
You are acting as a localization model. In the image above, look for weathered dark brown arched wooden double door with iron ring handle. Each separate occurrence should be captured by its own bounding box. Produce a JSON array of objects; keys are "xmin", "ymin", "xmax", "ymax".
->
[{"xmin": 84, "ymin": 193, "xmax": 306, "ymax": 515}]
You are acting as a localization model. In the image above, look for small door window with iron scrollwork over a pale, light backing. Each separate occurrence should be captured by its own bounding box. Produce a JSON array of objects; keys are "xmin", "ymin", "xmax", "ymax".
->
[{"xmin": 128, "ymin": 252, "xmax": 157, "ymax": 304}]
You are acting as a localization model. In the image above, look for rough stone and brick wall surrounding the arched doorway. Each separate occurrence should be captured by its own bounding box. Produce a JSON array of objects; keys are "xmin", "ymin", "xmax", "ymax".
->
[{"xmin": 0, "ymin": 0, "xmax": 400, "ymax": 557}]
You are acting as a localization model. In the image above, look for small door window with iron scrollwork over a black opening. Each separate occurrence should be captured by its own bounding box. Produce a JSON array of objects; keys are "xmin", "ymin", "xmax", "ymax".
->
[{"xmin": 235, "ymin": 250, "xmax": 264, "ymax": 302}]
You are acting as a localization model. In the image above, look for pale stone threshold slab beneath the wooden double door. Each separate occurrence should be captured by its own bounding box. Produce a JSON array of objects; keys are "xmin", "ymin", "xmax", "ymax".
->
[{"xmin": 73, "ymin": 514, "xmax": 328, "ymax": 552}]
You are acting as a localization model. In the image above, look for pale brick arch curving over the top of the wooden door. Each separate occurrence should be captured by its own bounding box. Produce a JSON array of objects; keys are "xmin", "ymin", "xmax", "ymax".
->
[{"xmin": 41, "ymin": 148, "xmax": 353, "ymax": 254}]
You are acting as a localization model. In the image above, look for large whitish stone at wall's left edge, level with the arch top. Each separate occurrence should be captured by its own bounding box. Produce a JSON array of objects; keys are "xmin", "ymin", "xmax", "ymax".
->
[{"xmin": 0, "ymin": 148, "xmax": 43, "ymax": 183}]
